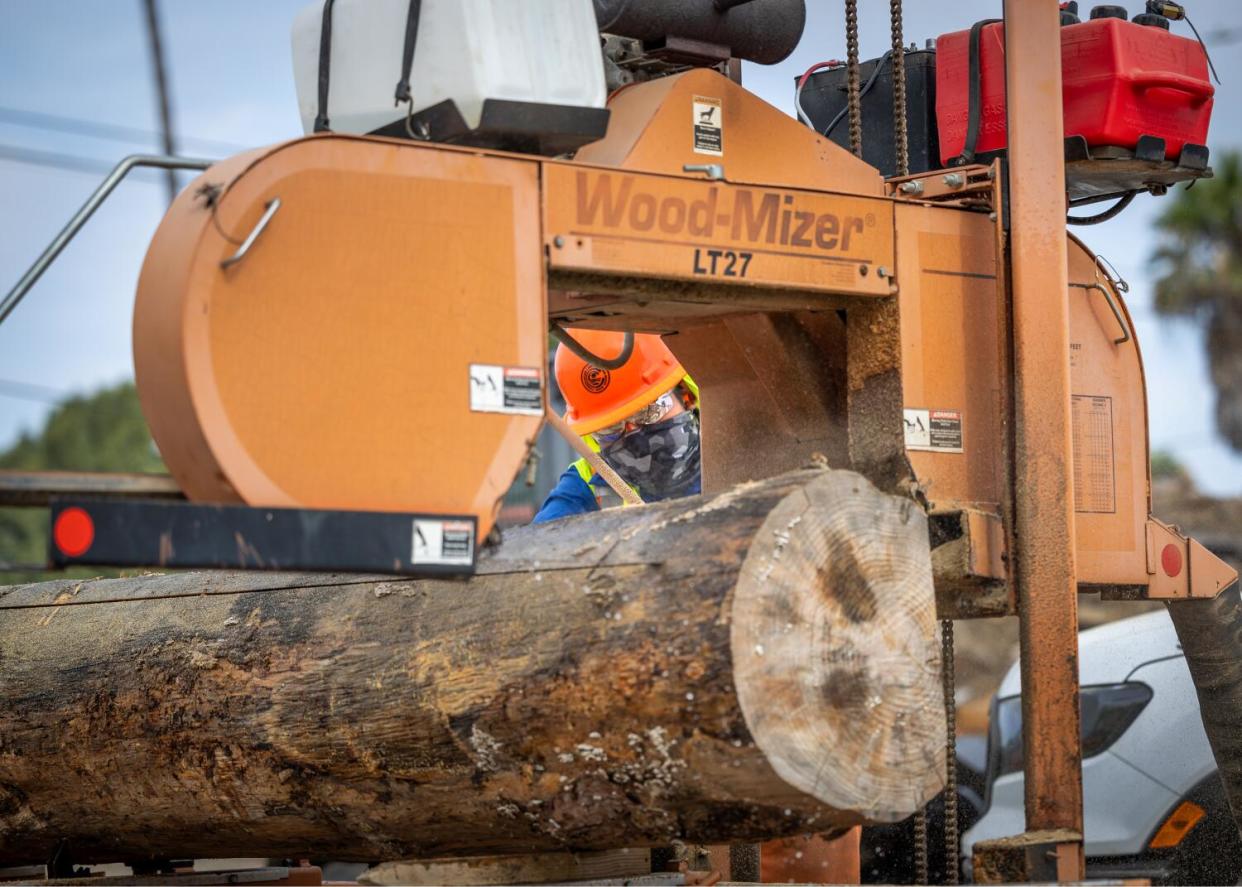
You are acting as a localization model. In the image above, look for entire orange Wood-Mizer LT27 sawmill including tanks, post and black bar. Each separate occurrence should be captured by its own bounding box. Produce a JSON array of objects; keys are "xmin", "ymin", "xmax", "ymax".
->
[{"xmin": 0, "ymin": 0, "xmax": 1236, "ymax": 880}]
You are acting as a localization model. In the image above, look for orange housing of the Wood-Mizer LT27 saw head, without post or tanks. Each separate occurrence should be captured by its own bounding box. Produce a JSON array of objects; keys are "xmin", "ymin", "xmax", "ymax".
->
[{"xmin": 134, "ymin": 70, "xmax": 1232, "ymax": 593}]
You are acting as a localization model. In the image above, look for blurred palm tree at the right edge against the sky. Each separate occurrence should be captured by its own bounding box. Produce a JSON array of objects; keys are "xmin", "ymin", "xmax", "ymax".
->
[{"xmin": 1153, "ymin": 152, "xmax": 1242, "ymax": 451}]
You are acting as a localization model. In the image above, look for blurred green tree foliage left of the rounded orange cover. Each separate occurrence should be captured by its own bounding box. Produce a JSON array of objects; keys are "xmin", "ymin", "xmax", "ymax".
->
[{"xmin": 0, "ymin": 383, "xmax": 164, "ymax": 585}]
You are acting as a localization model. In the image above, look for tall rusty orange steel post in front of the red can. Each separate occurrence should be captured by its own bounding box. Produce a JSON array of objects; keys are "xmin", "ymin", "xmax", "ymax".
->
[{"xmin": 1005, "ymin": 0, "xmax": 1083, "ymax": 881}]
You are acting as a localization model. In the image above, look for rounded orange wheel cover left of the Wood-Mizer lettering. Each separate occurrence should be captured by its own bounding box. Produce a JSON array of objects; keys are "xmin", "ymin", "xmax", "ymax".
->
[{"xmin": 134, "ymin": 137, "xmax": 546, "ymax": 538}]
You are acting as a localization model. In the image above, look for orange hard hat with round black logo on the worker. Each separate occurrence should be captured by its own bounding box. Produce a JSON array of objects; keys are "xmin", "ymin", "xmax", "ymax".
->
[{"xmin": 556, "ymin": 329, "xmax": 686, "ymax": 435}]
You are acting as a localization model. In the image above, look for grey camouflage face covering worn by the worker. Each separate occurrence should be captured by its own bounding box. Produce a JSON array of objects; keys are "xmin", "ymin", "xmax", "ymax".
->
[{"xmin": 600, "ymin": 411, "xmax": 699, "ymax": 502}]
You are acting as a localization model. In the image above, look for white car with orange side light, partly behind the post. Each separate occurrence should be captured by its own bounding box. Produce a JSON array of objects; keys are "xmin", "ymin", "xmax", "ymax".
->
[{"xmin": 961, "ymin": 610, "xmax": 1242, "ymax": 885}]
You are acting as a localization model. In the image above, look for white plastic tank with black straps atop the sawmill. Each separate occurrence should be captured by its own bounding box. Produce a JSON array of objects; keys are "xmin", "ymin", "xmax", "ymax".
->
[{"xmin": 286, "ymin": 0, "xmax": 607, "ymax": 133}]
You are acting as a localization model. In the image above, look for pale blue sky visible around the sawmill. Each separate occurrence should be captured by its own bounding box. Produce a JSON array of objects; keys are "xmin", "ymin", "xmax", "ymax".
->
[{"xmin": 0, "ymin": 0, "xmax": 1242, "ymax": 494}]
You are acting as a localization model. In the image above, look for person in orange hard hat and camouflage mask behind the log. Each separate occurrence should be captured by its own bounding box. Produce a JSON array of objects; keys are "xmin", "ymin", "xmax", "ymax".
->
[{"xmin": 534, "ymin": 329, "xmax": 700, "ymax": 523}]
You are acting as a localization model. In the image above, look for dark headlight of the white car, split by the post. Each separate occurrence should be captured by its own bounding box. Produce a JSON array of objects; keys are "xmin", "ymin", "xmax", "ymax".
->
[{"xmin": 987, "ymin": 682, "xmax": 1151, "ymax": 783}]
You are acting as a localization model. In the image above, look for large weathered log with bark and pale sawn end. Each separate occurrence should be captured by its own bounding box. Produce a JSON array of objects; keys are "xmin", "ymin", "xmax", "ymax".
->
[{"xmin": 0, "ymin": 470, "xmax": 945, "ymax": 865}]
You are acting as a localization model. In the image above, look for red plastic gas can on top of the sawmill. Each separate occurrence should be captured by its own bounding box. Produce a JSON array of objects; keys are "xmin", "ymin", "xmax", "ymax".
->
[{"xmin": 935, "ymin": 19, "xmax": 1215, "ymax": 165}]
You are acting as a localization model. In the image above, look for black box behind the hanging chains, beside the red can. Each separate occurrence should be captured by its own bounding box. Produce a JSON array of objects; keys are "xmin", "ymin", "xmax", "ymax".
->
[{"xmin": 794, "ymin": 50, "xmax": 940, "ymax": 176}]
